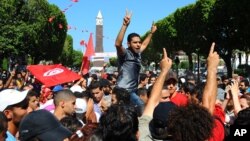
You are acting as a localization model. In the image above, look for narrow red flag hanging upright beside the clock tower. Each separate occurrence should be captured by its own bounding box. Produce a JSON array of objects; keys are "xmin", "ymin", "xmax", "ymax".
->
[{"xmin": 81, "ymin": 33, "xmax": 95, "ymax": 75}]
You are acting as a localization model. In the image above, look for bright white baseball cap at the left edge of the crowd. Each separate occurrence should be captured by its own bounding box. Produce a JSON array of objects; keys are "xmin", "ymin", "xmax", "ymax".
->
[{"xmin": 0, "ymin": 89, "xmax": 28, "ymax": 111}]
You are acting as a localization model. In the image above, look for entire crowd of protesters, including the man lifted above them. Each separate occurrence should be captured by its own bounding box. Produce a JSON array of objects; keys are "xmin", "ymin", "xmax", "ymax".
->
[{"xmin": 0, "ymin": 12, "xmax": 250, "ymax": 141}]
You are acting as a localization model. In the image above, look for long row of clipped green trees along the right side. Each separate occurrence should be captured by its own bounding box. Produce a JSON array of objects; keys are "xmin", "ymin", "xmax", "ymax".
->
[{"xmin": 142, "ymin": 0, "xmax": 250, "ymax": 77}]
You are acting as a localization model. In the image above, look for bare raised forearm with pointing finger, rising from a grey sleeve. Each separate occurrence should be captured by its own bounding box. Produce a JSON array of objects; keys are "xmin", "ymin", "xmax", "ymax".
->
[{"xmin": 143, "ymin": 48, "xmax": 172, "ymax": 117}]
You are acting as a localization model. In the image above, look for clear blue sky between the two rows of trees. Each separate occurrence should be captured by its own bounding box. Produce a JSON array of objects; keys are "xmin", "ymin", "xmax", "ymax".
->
[{"xmin": 48, "ymin": 0, "xmax": 196, "ymax": 52}]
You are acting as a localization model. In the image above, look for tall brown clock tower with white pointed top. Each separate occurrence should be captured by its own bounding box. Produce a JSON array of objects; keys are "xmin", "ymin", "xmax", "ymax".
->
[{"xmin": 93, "ymin": 11, "xmax": 104, "ymax": 67}]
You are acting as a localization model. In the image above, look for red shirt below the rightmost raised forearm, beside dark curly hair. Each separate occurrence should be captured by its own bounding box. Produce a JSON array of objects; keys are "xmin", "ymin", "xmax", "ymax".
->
[{"xmin": 209, "ymin": 105, "xmax": 225, "ymax": 141}]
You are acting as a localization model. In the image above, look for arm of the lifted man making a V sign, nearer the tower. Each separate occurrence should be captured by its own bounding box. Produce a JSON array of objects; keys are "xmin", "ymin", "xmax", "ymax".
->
[{"xmin": 115, "ymin": 10, "xmax": 132, "ymax": 54}]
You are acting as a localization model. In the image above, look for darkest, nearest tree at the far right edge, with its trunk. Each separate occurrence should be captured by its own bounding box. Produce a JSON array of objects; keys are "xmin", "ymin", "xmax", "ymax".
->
[{"xmin": 209, "ymin": 0, "xmax": 250, "ymax": 77}]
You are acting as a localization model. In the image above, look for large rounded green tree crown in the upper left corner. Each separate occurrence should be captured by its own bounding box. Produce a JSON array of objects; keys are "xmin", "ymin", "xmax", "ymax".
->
[{"xmin": 0, "ymin": 0, "xmax": 67, "ymax": 63}]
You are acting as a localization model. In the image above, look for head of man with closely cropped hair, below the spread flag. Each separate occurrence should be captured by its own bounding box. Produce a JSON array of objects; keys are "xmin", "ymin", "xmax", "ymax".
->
[{"xmin": 54, "ymin": 89, "xmax": 76, "ymax": 115}]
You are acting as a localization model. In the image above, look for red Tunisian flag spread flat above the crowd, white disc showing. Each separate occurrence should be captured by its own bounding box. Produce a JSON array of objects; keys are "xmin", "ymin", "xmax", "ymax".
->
[{"xmin": 27, "ymin": 64, "xmax": 81, "ymax": 87}]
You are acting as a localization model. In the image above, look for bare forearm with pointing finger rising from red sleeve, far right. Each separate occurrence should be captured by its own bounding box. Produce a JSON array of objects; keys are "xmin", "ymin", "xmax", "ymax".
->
[{"xmin": 202, "ymin": 43, "xmax": 220, "ymax": 114}]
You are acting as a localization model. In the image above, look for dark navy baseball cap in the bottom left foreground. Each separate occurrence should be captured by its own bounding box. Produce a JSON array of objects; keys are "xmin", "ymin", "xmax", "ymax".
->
[{"xmin": 19, "ymin": 109, "xmax": 72, "ymax": 141}]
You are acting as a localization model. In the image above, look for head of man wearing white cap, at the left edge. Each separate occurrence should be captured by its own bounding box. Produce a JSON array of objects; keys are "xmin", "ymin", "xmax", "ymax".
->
[{"xmin": 0, "ymin": 89, "xmax": 28, "ymax": 128}]
